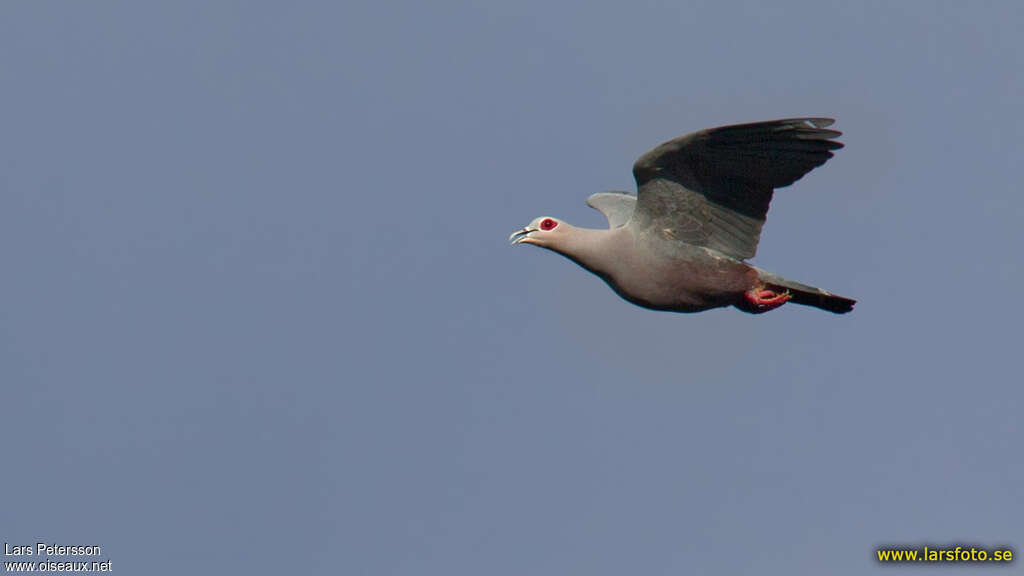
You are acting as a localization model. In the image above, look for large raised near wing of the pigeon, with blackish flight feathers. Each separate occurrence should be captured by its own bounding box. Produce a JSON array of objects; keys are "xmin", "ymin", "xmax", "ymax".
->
[{"xmin": 630, "ymin": 118, "xmax": 843, "ymax": 259}]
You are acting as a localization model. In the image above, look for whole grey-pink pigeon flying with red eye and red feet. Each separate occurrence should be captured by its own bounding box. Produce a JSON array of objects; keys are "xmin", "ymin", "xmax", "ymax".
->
[{"xmin": 509, "ymin": 118, "xmax": 856, "ymax": 314}]
